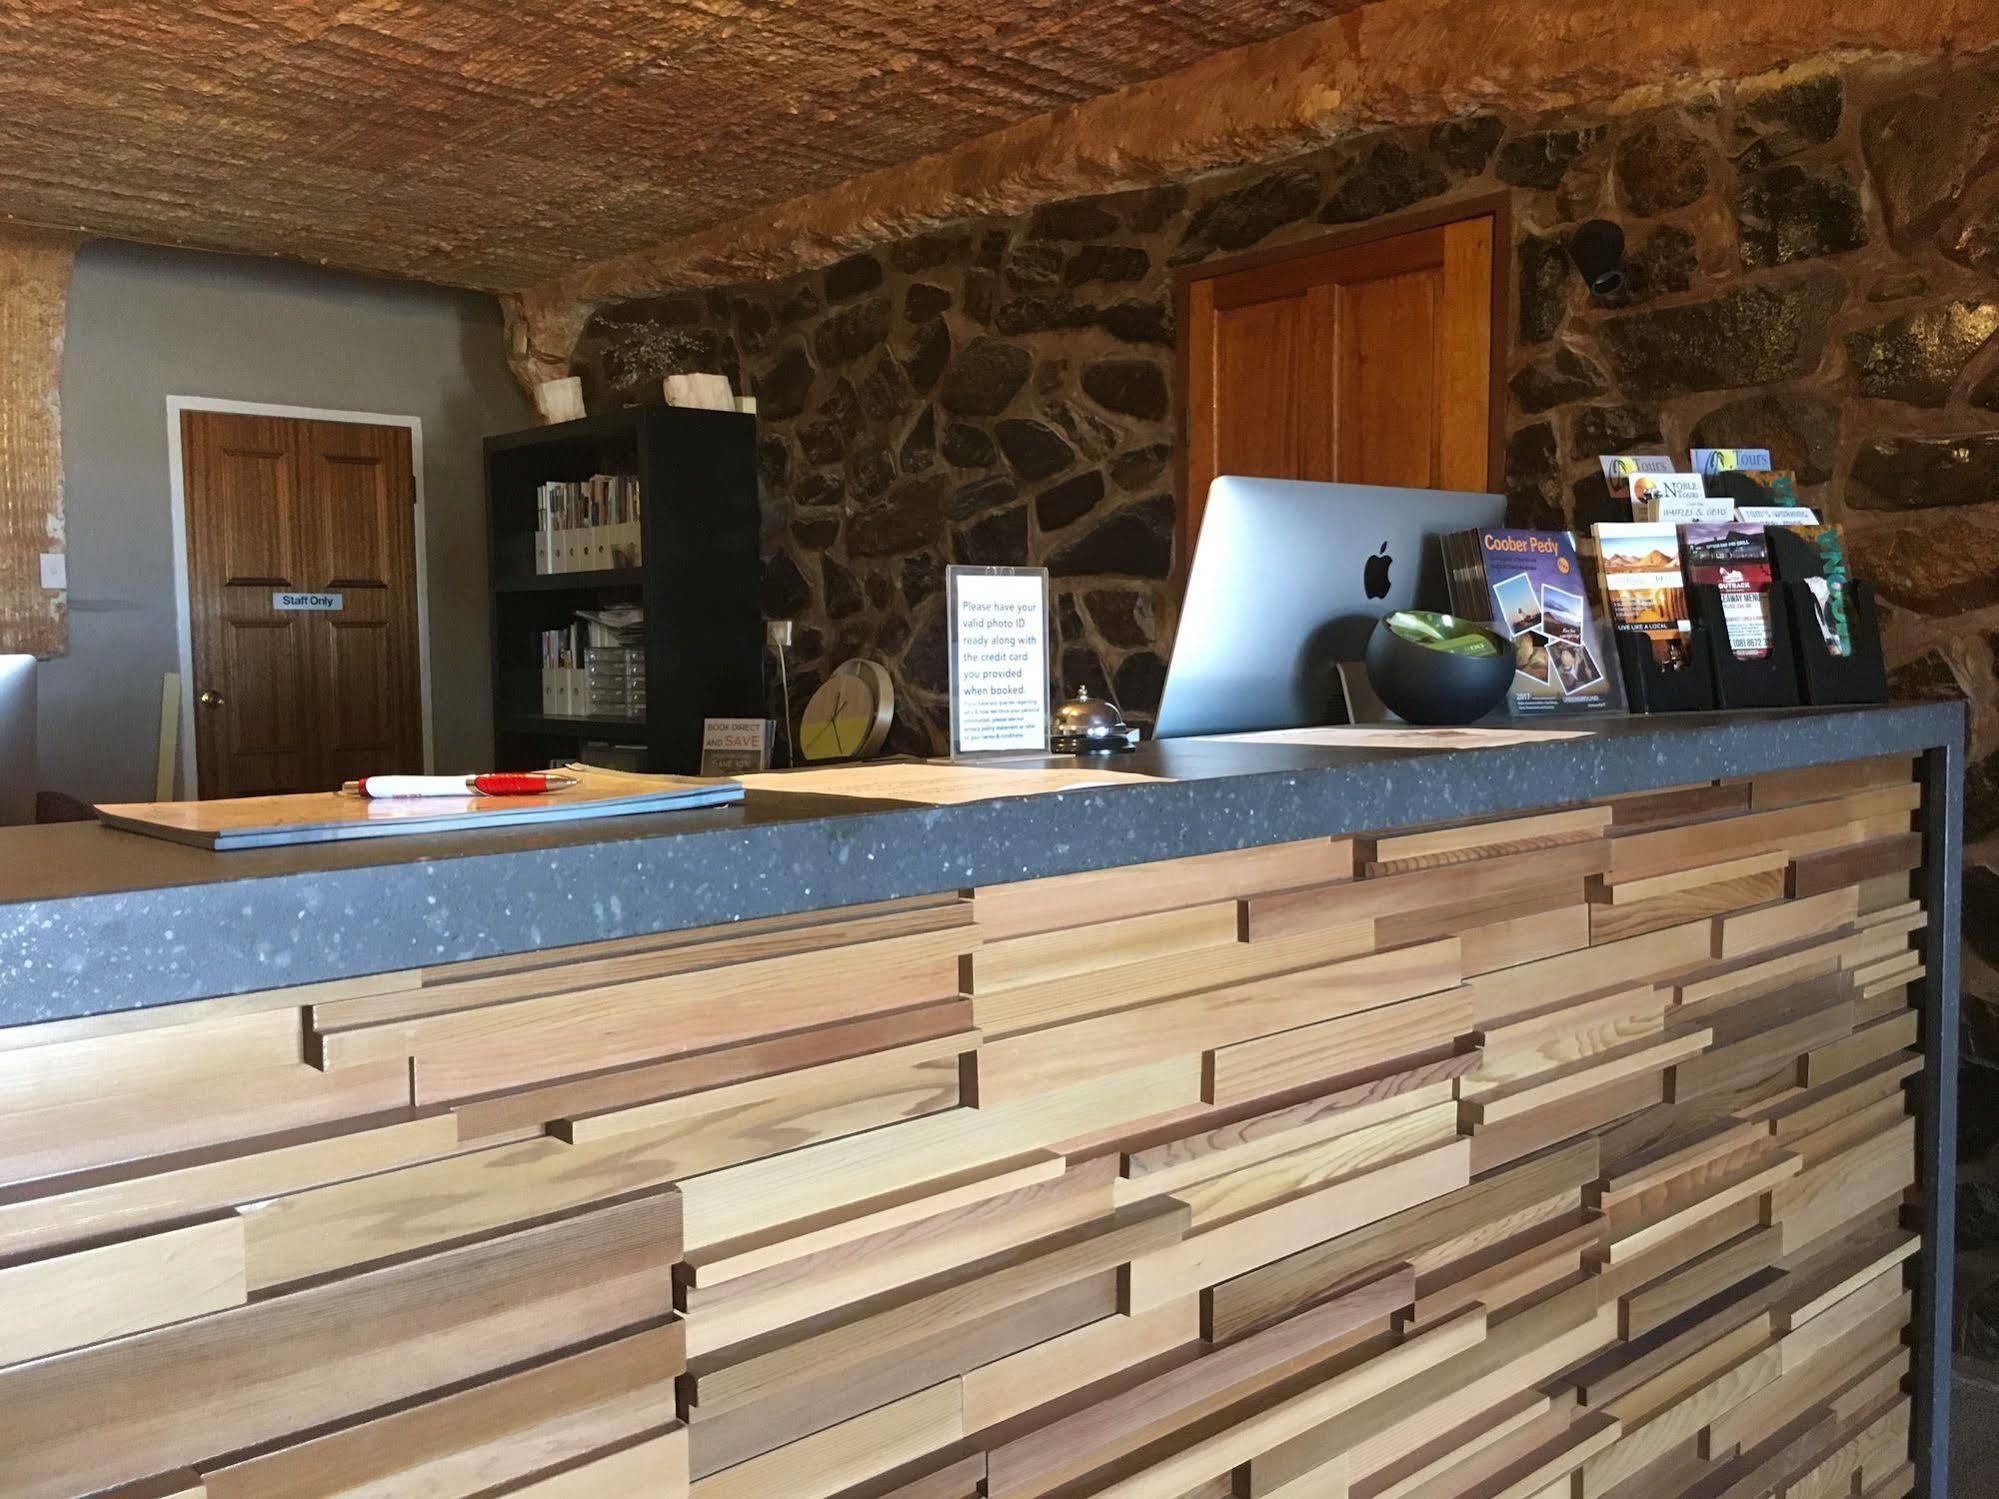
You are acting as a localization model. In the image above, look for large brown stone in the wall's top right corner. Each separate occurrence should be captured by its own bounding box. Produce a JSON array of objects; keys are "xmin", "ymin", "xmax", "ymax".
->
[{"xmin": 1861, "ymin": 70, "xmax": 1999, "ymax": 250}]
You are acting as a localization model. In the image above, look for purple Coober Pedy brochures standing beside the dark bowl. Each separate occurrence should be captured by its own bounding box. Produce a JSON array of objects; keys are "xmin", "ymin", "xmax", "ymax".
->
[{"xmin": 1445, "ymin": 530, "xmax": 1623, "ymax": 716}]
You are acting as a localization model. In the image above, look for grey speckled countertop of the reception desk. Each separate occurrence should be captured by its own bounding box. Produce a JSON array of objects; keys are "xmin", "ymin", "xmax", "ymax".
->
[{"xmin": 0, "ymin": 704, "xmax": 1965, "ymax": 1025}]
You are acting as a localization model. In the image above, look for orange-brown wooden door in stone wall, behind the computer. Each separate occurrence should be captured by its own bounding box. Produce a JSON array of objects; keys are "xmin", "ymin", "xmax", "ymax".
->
[{"xmin": 1181, "ymin": 214, "xmax": 1495, "ymax": 558}]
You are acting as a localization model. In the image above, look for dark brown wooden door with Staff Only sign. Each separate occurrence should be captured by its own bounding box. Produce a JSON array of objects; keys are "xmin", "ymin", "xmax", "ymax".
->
[{"xmin": 182, "ymin": 412, "xmax": 422, "ymax": 797}]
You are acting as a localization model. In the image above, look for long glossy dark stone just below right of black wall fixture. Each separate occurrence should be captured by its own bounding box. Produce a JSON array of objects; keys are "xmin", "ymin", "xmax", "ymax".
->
[{"xmin": 1597, "ymin": 272, "xmax": 1845, "ymax": 400}]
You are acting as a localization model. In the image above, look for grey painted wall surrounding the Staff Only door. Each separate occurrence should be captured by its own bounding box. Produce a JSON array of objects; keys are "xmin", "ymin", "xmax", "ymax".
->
[{"xmin": 51, "ymin": 242, "xmax": 534, "ymax": 801}]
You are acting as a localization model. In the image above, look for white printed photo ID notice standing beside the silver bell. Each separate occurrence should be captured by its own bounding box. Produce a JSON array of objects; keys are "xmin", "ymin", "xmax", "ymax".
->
[{"xmin": 946, "ymin": 568, "xmax": 1047, "ymax": 755}]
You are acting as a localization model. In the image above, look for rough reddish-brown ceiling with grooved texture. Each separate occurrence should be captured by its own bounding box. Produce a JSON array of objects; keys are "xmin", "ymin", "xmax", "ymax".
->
[{"xmin": 0, "ymin": 0, "xmax": 1361, "ymax": 290}]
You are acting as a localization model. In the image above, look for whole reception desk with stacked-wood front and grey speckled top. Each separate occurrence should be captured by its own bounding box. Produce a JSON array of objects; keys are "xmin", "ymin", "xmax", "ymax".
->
[{"xmin": 0, "ymin": 706, "xmax": 1963, "ymax": 1499}]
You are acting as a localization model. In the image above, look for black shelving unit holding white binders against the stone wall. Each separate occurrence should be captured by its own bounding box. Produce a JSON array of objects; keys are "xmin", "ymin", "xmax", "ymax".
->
[{"xmin": 486, "ymin": 406, "xmax": 764, "ymax": 773}]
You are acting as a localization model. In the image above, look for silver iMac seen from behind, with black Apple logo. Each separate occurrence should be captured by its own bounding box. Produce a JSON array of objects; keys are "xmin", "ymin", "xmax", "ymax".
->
[{"xmin": 1153, "ymin": 476, "xmax": 1505, "ymax": 740}]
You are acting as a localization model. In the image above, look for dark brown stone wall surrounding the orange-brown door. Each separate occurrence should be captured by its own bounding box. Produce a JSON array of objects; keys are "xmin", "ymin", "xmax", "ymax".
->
[{"xmin": 580, "ymin": 58, "xmax": 1999, "ymax": 1031}]
